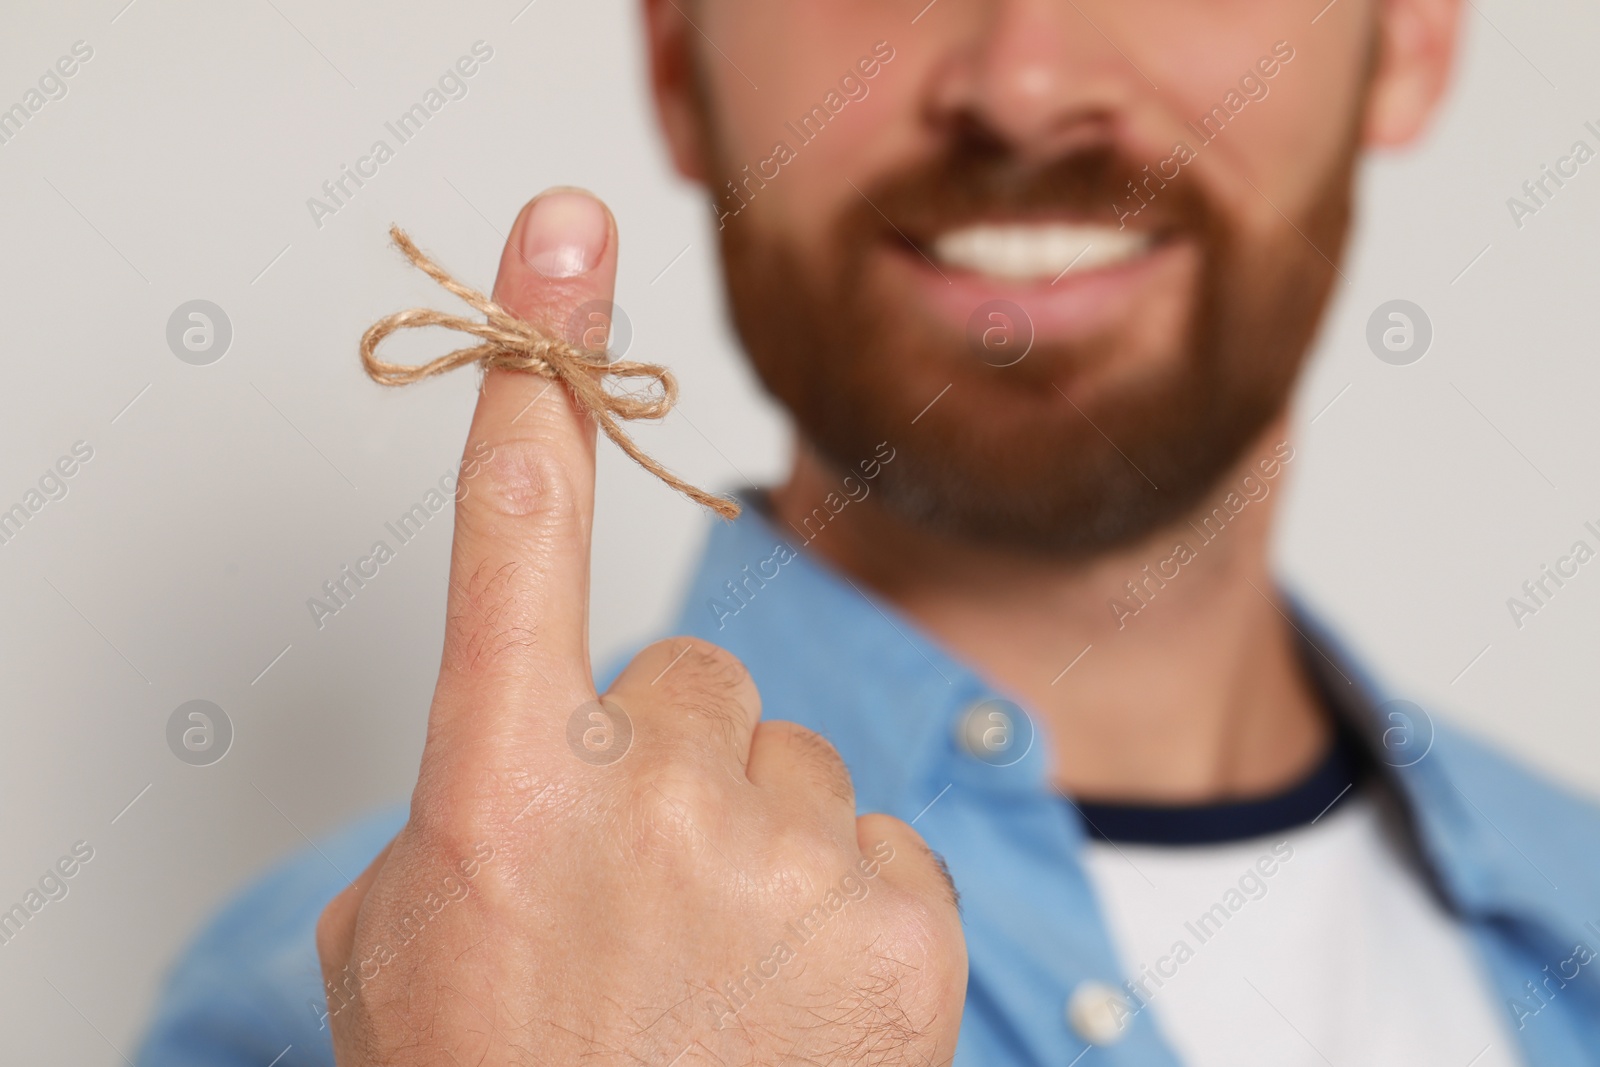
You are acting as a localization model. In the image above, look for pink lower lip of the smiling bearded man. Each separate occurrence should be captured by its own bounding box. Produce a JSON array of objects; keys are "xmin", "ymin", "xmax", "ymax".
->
[{"xmin": 890, "ymin": 240, "xmax": 1194, "ymax": 342}]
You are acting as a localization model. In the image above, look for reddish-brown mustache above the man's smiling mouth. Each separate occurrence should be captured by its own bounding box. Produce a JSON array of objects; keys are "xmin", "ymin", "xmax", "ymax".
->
[{"xmin": 846, "ymin": 133, "xmax": 1219, "ymax": 243}]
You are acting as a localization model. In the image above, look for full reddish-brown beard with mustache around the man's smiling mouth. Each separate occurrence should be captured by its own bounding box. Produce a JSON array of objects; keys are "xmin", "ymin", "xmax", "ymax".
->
[{"xmin": 709, "ymin": 130, "xmax": 1357, "ymax": 560}]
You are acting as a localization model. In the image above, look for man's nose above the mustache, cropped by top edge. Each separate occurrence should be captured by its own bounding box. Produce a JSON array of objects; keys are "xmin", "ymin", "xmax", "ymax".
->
[{"xmin": 931, "ymin": 0, "xmax": 1155, "ymax": 160}]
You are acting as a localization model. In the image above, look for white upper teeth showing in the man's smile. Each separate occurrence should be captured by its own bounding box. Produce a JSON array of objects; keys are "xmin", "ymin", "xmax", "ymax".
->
[{"xmin": 933, "ymin": 222, "xmax": 1150, "ymax": 282}]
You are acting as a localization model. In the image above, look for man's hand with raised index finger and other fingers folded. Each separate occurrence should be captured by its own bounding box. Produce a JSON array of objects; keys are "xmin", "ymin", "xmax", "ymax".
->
[{"xmin": 317, "ymin": 190, "xmax": 966, "ymax": 1067}]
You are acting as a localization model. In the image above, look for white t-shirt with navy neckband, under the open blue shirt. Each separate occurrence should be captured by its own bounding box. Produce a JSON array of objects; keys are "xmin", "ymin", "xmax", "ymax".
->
[{"xmin": 1085, "ymin": 793, "xmax": 1522, "ymax": 1067}]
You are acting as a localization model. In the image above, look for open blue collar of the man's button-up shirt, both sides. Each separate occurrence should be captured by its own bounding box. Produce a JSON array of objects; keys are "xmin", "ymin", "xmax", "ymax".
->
[{"xmin": 678, "ymin": 494, "xmax": 1571, "ymax": 925}]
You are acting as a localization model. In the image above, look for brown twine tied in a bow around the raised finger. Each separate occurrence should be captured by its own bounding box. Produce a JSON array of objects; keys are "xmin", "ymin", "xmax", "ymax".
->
[{"xmin": 362, "ymin": 226, "xmax": 739, "ymax": 518}]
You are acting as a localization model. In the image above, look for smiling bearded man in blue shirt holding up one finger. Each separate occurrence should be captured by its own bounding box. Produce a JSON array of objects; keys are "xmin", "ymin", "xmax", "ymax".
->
[{"xmin": 142, "ymin": 0, "xmax": 1600, "ymax": 1067}]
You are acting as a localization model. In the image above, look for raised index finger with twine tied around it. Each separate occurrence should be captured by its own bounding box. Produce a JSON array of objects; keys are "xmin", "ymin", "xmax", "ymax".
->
[{"xmin": 429, "ymin": 189, "xmax": 618, "ymax": 742}]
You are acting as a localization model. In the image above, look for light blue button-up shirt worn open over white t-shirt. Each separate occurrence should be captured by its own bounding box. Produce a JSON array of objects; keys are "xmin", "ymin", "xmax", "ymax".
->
[{"xmin": 139, "ymin": 509, "xmax": 1600, "ymax": 1067}]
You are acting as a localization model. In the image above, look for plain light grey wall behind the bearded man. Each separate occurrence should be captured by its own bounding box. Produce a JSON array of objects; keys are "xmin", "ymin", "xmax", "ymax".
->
[{"xmin": 0, "ymin": 0, "xmax": 1600, "ymax": 1064}]
